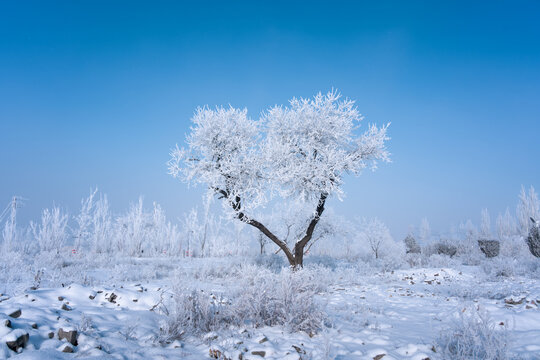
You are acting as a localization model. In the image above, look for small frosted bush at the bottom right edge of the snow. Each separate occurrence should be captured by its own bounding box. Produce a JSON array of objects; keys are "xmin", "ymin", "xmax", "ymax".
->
[{"xmin": 435, "ymin": 306, "xmax": 509, "ymax": 360}]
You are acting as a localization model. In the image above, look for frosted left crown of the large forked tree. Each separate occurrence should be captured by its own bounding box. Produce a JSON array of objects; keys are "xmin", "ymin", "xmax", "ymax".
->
[{"xmin": 168, "ymin": 107, "xmax": 265, "ymax": 217}]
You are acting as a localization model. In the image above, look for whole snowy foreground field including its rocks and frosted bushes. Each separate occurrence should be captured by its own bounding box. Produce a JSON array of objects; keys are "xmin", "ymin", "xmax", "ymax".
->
[{"xmin": 0, "ymin": 258, "xmax": 540, "ymax": 360}]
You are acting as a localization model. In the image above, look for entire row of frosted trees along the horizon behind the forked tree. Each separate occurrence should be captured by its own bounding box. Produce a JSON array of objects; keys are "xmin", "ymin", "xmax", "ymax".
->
[{"xmin": 1, "ymin": 188, "xmax": 540, "ymax": 262}]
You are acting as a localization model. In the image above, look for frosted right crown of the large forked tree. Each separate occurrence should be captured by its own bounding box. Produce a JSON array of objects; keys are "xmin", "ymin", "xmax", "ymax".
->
[{"xmin": 262, "ymin": 91, "xmax": 389, "ymax": 199}]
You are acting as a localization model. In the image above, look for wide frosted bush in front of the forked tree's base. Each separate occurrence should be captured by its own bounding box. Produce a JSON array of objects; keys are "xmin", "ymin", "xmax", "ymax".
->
[{"xmin": 161, "ymin": 266, "xmax": 326, "ymax": 340}]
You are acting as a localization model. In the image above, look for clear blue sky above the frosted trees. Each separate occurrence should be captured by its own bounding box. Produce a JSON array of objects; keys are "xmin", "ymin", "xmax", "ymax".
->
[{"xmin": 0, "ymin": 1, "xmax": 540, "ymax": 236}]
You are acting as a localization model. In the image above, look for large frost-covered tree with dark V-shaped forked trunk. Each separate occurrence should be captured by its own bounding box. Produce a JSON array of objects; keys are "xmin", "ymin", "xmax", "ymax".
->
[{"xmin": 169, "ymin": 91, "xmax": 389, "ymax": 267}]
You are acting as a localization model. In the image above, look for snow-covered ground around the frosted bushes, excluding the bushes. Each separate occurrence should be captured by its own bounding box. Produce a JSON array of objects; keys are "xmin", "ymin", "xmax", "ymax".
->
[{"xmin": 0, "ymin": 259, "xmax": 540, "ymax": 360}]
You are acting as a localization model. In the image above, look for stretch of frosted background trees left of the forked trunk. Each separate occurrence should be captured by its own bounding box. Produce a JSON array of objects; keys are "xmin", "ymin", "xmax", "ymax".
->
[{"xmin": 1, "ymin": 190, "xmax": 241, "ymax": 257}]
